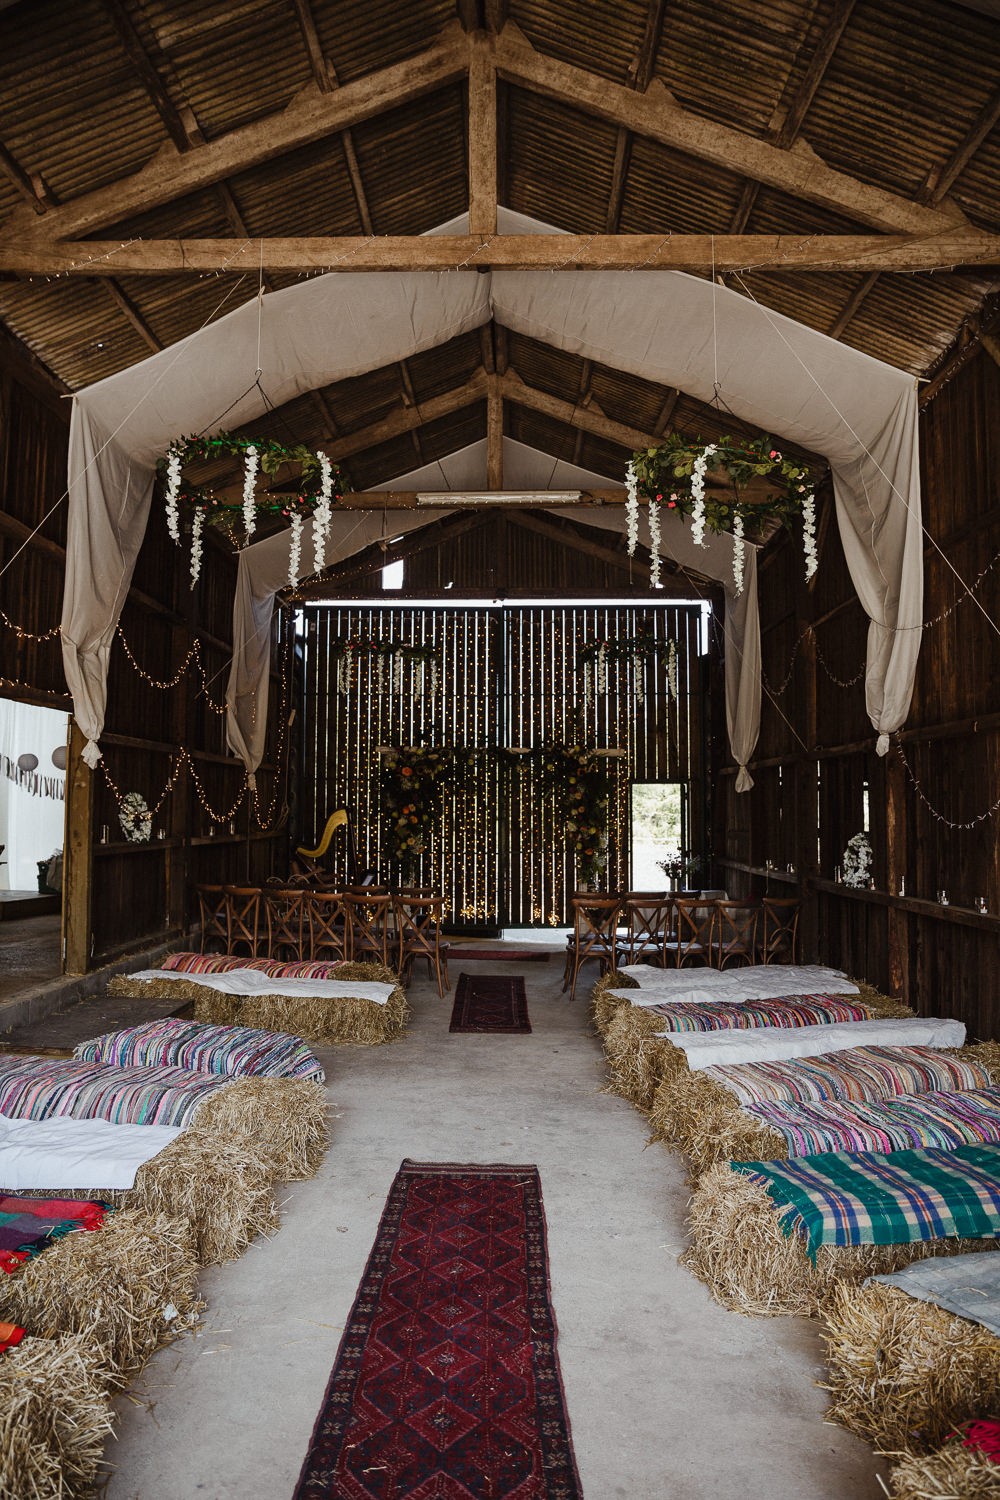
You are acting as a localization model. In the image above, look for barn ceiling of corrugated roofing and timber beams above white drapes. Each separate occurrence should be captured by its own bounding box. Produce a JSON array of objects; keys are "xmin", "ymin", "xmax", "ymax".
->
[{"xmin": 0, "ymin": 0, "xmax": 1000, "ymax": 555}]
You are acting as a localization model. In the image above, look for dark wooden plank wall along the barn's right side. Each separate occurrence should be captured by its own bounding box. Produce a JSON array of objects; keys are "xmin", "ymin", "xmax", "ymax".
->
[{"xmin": 715, "ymin": 351, "xmax": 1000, "ymax": 1037}]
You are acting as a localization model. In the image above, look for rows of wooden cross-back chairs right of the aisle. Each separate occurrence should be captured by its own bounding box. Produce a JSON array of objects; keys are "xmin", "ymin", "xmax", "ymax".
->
[{"xmin": 562, "ymin": 891, "xmax": 801, "ymax": 999}]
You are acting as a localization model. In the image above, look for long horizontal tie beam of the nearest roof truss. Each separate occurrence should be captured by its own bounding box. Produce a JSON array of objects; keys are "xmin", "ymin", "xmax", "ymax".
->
[{"xmin": 0, "ymin": 231, "xmax": 1000, "ymax": 276}]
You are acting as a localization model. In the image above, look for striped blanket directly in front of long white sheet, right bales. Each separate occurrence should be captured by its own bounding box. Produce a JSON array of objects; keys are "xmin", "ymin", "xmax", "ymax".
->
[{"xmin": 705, "ymin": 1047, "xmax": 993, "ymax": 1109}]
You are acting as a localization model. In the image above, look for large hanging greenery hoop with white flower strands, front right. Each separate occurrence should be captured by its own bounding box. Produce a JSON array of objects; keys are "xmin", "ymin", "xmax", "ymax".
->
[{"xmin": 625, "ymin": 432, "xmax": 819, "ymax": 594}]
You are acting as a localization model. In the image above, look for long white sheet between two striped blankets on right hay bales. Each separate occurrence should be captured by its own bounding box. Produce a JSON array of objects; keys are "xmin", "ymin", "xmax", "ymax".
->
[{"xmin": 661, "ymin": 1016, "xmax": 966, "ymax": 1071}]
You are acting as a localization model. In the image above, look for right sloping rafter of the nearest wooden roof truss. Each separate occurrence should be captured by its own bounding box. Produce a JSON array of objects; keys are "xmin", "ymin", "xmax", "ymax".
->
[{"xmin": 496, "ymin": 21, "xmax": 967, "ymax": 234}]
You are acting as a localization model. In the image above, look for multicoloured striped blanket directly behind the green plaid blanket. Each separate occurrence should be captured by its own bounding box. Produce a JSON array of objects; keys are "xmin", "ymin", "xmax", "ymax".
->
[{"xmin": 747, "ymin": 1089, "xmax": 1000, "ymax": 1157}]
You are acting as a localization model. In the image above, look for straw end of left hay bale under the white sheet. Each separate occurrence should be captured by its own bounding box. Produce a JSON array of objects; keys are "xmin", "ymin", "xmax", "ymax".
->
[{"xmin": 127, "ymin": 1125, "xmax": 279, "ymax": 1266}]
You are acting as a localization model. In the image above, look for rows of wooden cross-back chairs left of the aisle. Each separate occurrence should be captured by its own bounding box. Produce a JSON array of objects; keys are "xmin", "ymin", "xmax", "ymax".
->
[{"xmin": 196, "ymin": 885, "xmax": 450, "ymax": 995}]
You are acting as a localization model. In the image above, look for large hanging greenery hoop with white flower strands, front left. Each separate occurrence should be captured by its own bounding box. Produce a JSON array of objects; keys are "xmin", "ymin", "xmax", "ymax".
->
[{"xmin": 156, "ymin": 432, "xmax": 343, "ymax": 588}]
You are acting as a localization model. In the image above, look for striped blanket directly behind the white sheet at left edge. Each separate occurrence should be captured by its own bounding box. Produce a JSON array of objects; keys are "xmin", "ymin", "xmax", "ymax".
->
[{"xmin": 0, "ymin": 1056, "xmax": 231, "ymax": 1125}]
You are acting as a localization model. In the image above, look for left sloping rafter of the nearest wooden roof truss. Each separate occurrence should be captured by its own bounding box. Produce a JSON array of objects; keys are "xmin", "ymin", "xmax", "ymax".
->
[{"xmin": 4, "ymin": 21, "xmax": 469, "ymax": 239}]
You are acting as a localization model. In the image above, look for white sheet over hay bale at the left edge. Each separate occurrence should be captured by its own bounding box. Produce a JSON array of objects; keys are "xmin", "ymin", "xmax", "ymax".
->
[{"xmin": 0, "ymin": 1116, "xmax": 183, "ymax": 1193}]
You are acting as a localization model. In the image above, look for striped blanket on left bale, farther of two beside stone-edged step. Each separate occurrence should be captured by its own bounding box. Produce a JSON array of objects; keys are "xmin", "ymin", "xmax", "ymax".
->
[{"xmin": 73, "ymin": 1017, "xmax": 325, "ymax": 1083}]
